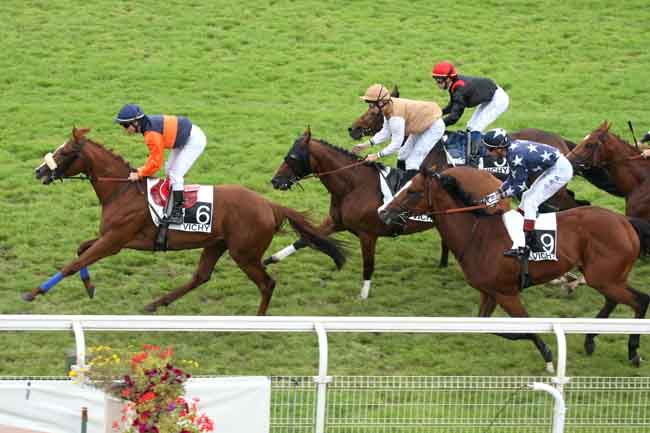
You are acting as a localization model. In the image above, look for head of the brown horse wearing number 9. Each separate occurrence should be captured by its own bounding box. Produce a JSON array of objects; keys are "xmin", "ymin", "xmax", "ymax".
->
[{"xmin": 379, "ymin": 165, "xmax": 440, "ymax": 226}]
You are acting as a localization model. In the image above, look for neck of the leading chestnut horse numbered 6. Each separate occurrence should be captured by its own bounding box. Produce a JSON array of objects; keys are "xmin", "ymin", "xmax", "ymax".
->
[{"xmin": 82, "ymin": 143, "xmax": 130, "ymax": 204}]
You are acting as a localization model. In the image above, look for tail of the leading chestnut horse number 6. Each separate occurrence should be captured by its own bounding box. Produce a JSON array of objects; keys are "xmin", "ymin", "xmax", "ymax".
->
[{"xmin": 271, "ymin": 203, "xmax": 346, "ymax": 269}]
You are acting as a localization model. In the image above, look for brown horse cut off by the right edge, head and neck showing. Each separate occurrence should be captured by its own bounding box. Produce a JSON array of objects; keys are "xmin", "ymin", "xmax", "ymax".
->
[{"xmin": 567, "ymin": 122, "xmax": 650, "ymax": 220}]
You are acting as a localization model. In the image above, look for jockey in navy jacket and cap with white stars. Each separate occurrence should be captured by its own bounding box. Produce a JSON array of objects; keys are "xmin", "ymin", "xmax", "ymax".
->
[{"xmin": 481, "ymin": 128, "xmax": 573, "ymax": 257}]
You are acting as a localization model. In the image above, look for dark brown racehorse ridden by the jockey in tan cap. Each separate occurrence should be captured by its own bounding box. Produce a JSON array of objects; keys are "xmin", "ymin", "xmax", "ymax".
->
[{"xmin": 265, "ymin": 128, "xmax": 510, "ymax": 299}]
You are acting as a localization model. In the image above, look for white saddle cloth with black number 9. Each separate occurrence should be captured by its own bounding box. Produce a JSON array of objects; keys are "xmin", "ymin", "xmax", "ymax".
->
[{"xmin": 503, "ymin": 210, "xmax": 558, "ymax": 262}]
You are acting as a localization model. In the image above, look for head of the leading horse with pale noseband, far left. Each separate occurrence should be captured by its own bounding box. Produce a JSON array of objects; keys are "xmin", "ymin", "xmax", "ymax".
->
[{"xmin": 35, "ymin": 127, "xmax": 90, "ymax": 185}]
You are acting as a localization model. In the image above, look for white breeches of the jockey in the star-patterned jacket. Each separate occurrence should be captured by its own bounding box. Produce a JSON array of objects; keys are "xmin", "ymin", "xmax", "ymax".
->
[{"xmin": 519, "ymin": 155, "xmax": 573, "ymax": 220}]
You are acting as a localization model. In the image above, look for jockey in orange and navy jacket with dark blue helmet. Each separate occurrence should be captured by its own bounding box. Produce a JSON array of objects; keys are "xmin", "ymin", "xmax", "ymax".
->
[{"xmin": 115, "ymin": 104, "xmax": 206, "ymax": 224}]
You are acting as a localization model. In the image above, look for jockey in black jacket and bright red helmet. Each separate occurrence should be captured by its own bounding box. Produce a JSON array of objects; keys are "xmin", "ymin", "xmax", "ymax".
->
[{"xmin": 431, "ymin": 62, "xmax": 510, "ymax": 160}]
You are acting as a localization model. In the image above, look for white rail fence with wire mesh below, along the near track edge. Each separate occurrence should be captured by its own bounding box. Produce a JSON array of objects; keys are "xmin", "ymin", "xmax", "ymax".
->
[{"xmin": 0, "ymin": 315, "xmax": 650, "ymax": 433}]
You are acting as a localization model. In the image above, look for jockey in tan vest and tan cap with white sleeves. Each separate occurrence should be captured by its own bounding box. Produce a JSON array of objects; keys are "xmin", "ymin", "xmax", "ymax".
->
[{"xmin": 352, "ymin": 84, "xmax": 445, "ymax": 178}]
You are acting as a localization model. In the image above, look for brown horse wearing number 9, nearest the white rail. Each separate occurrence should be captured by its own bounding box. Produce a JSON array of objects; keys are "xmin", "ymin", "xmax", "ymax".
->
[{"xmin": 381, "ymin": 167, "xmax": 650, "ymax": 368}]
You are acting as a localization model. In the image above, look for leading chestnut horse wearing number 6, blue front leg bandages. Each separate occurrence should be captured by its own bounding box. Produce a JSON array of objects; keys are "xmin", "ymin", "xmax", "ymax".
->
[{"xmin": 23, "ymin": 128, "xmax": 345, "ymax": 315}]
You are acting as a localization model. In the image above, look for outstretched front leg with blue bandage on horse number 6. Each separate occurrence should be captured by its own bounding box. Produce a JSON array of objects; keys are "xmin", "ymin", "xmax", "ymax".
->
[{"xmin": 21, "ymin": 233, "xmax": 126, "ymax": 302}]
